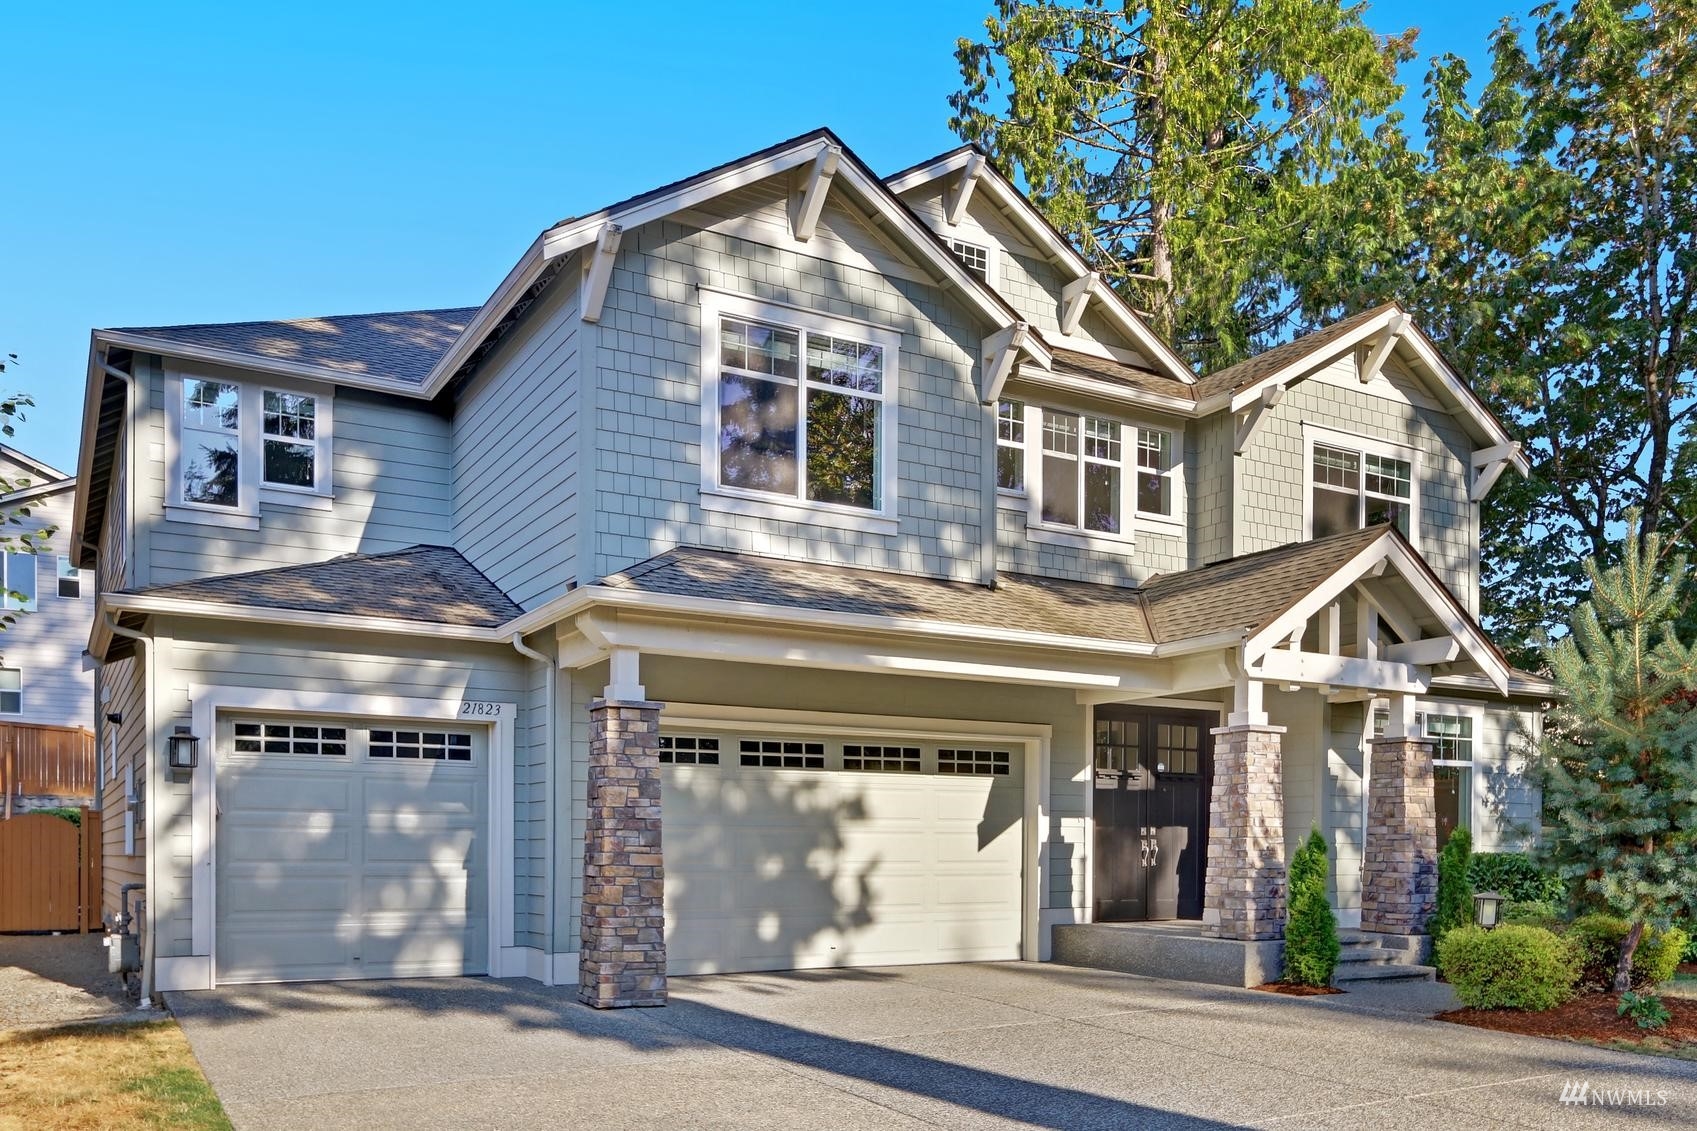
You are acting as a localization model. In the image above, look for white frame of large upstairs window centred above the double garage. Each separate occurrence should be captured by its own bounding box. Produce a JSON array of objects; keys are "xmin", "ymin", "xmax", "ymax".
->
[{"xmin": 699, "ymin": 287, "xmax": 901, "ymax": 535}]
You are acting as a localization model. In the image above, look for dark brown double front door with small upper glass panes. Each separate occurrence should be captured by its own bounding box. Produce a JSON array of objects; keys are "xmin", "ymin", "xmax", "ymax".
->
[{"xmin": 1095, "ymin": 706, "xmax": 1218, "ymax": 922}]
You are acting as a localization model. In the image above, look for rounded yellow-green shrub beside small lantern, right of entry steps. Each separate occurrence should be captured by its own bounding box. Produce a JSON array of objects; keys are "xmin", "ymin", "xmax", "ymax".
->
[{"xmin": 1437, "ymin": 924, "xmax": 1580, "ymax": 1012}]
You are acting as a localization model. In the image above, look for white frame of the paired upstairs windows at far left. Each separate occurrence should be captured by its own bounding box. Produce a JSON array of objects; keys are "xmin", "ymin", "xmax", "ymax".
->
[{"xmin": 165, "ymin": 369, "xmax": 334, "ymax": 530}]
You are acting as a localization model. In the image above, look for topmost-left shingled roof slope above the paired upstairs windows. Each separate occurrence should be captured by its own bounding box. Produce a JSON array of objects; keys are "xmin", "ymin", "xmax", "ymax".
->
[{"xmin": 114, "ymin": 306, "xmax": 479, "ymax": 385}]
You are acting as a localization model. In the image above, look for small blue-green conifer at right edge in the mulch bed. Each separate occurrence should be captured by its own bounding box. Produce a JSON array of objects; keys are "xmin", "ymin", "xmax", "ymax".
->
[{"xmin": 1539, "ymin": 511, "xmax": 1697, "ymax": 992}]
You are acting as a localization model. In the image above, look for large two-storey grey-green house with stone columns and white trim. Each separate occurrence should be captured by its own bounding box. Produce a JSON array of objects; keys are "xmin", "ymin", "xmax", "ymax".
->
[{"xmin": 73, "ymin": 131, "xmax": 1549, "ymax": 1005}]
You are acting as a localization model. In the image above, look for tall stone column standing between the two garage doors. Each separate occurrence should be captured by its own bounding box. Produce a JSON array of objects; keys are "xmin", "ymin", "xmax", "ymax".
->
[{"xmin": 577, "ymin": 700, "xmax": 665, "ymax": 1009}]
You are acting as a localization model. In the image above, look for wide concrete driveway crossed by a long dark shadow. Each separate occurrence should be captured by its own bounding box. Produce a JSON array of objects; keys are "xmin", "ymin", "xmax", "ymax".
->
[{"xmin": 170, "ymin": 963, "xmax": 1697, "ymax": 1131}]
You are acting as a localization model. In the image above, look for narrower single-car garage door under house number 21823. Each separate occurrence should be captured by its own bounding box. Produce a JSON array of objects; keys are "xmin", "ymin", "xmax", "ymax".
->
[{"xmin": 216, "ymin": 717, "xmax": 489, "ymax": 982}]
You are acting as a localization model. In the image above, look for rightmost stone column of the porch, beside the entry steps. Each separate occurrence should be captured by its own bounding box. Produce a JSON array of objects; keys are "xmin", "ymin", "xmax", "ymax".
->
[{"xmin": 1361, "ymin": 737, "xmax": 1437, "ymax": 934}]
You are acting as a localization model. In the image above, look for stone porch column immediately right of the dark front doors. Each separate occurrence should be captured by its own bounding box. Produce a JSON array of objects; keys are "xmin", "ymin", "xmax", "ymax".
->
[{"xmin": 1201, "ymin": 723, "xmax": 1285, "ymax": 939}]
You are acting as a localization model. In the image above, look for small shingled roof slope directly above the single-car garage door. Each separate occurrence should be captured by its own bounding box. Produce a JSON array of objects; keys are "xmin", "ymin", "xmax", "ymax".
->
[{"xmin": 126, "ymin": 545, "xmax": 524, "ymax": 628}]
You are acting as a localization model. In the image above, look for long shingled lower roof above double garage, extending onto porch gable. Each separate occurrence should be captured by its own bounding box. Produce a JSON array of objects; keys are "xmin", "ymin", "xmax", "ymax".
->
[{"xmin": 601, "ymin": 526, "xmax": 1390, "ymax": 644}]
